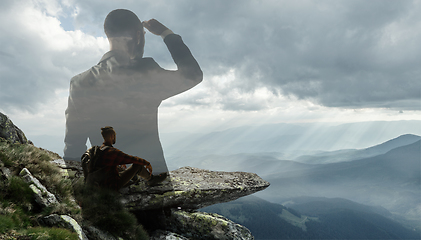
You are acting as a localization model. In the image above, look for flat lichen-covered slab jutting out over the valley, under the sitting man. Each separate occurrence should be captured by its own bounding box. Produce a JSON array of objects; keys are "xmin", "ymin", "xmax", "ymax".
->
[{"xmin": 121, "ymin": 167, "xmax": 270, "ymax": 211}]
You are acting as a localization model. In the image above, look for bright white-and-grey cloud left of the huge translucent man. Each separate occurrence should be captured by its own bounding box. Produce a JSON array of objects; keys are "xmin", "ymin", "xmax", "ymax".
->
[{"xmin": 0, "ymin": 1, "xmax": 108, "ymax": 113}]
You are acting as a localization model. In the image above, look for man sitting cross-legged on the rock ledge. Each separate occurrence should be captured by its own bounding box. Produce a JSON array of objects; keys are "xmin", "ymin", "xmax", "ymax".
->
[{"xmin": 86, "ymin": 126, "xmax": 167, "ymax": 191}]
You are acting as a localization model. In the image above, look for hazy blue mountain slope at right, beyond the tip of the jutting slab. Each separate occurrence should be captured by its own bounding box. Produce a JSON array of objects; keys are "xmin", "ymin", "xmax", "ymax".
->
[{"xmin": 258, "ymin": 141, "xmax": 421, "ymax": 222}]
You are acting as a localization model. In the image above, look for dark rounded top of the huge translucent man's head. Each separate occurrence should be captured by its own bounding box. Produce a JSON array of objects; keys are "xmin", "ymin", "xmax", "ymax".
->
[{"xmin": 104, "ymin": 9, "xmax": 143, "ymax": 38}]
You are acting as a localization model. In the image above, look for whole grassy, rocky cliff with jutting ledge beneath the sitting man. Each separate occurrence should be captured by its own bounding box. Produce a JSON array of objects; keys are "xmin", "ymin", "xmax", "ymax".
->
[{"xmin": 0, "ymin": 112, "xmax": 269, "ymax": 240}]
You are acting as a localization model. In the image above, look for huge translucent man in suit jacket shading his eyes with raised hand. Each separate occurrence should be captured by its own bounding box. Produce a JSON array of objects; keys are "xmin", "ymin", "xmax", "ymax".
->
[{"xmin": 63, "ymin": 9, "xmax": 203, "ymax": 174}]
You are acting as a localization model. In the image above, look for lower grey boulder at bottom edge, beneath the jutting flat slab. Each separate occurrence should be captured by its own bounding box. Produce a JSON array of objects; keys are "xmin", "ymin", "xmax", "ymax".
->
[{"xmin": 162, "ymin": 210, "xmax": 254, "ymax": 240}]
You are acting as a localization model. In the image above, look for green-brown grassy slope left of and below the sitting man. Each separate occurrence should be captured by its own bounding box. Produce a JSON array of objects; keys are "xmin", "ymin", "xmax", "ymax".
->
[{"xmin": 0, "ymin": 138, "xmax": 149, "ymax": 240}]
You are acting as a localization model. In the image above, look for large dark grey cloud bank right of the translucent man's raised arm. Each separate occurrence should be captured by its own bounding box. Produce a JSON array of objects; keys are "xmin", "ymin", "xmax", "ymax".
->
[{"xmin": 125, "ymin": 1, "xmax": 421, "ymax": 109}]
